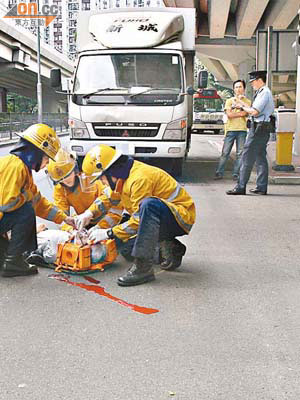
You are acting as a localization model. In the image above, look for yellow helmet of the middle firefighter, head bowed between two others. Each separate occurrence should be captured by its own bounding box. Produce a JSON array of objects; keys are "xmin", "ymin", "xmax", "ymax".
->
[{"xmin": 47, "ymin": 149, "xmax": 77, "ymax": 183}]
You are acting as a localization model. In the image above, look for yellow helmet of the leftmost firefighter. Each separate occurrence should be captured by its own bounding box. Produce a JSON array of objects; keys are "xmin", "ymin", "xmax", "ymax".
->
[{"xmin": 17, "ymin": 124, "xmax": 60, "ymax": 160}]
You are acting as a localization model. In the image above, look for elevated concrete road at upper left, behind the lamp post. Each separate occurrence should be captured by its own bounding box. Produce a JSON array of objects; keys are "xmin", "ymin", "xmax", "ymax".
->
[{"xmin": 0, "ymin": 18, "xmax": 73, "ymax": 112}]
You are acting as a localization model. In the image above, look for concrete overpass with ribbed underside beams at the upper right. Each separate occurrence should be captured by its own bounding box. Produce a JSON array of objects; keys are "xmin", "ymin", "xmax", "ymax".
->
[{"xmin": 164, "ymin": 0, "xmax": 300, "ymax": 107}]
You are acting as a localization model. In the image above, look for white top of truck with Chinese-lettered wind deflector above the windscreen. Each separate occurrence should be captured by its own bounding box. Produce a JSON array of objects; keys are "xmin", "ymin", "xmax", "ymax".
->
[{"xmin": 77, "ymin": 7, "xmax": 195, "ymax": 51}]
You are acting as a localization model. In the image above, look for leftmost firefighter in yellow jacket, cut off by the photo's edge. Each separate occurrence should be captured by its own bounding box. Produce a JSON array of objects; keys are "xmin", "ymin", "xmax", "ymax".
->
[{"xmin": 0, "ymin": 124, "xmax": 74, "ymax": 277}]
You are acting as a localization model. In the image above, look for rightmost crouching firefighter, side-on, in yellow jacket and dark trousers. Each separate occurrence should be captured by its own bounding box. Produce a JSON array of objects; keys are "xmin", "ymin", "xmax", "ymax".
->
[{"xmin": 76, "ymin": 145, "xmax": 195, "ymax": 286}]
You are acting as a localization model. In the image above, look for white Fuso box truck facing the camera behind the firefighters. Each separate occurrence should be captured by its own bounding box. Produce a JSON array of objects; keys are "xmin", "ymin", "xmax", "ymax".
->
[{"xmin": 51, "ymin": 8, "xmax": 195, "ymax": 176}]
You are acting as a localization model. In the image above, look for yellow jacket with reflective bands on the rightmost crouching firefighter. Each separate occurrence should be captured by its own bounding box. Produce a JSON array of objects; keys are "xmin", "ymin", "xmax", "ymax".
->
[{"xmin": 89, "ymin": 161, "xmax": 196, "ymax": 241}]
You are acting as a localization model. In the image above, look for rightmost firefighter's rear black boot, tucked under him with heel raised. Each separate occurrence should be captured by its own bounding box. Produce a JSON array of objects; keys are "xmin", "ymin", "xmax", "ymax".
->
[{"xmin": 160, "ymin": 239, "xmax": 186, "ymax": 271}]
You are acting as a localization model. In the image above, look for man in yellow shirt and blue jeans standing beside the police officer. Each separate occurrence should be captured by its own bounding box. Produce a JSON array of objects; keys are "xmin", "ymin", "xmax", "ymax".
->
[{"xmin": 215, "ymin": 79, "xmax": 251, "ymax": 180}]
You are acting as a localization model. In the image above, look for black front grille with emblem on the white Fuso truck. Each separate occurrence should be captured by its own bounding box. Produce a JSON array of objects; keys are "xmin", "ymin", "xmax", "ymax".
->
[{"xmin": 93, "ymin": 123, "xmax": 160, "ymax": 139}]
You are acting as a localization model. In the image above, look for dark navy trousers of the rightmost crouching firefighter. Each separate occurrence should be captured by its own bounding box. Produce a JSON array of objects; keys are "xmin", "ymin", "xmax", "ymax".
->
[{"xmin": 116, "ymin": 197, "xmax": 186, "ymax": 262}]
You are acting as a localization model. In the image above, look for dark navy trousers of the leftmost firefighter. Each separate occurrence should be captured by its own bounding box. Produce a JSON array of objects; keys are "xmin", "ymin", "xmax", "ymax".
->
[{"xmin": 0, "ymin": 203, "xmax": 37, "ymax": 256}]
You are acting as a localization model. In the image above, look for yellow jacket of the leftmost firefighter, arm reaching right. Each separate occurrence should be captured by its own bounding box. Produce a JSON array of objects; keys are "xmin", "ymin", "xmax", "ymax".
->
[{"xmin": 0, "ymin": 154, "xmax": 67, "ymax": 224}]
